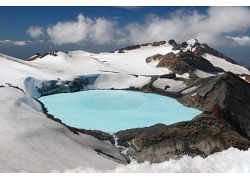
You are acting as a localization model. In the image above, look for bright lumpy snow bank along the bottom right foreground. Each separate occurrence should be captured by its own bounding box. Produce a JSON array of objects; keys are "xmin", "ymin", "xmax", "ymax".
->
[{"xmin": 57, "ymin": 147, "xmax": 250, "ymax": 173}]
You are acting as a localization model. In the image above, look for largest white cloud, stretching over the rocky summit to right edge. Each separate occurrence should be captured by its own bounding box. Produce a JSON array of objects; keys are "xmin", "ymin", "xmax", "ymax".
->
[{"xmin": 126, "ymin": 7, "xmax": 250, "ymax": 46}]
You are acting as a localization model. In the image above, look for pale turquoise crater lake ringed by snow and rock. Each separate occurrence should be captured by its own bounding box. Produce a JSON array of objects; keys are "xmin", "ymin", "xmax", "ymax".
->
[{"xmin": 39, "ymin": 90, "xmax": 201, "ymax": 133}]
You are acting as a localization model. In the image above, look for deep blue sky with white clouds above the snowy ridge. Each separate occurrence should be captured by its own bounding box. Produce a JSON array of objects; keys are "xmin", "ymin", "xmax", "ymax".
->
[{"xmin": 0, "ymin": 7, "xmax": 250, "ymax": 66}]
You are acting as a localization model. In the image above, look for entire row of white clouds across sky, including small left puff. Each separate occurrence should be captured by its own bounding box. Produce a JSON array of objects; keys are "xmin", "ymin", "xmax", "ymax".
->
[{"xmin": 27, "ymin": 7, "xmax": 250, "ymax": 47}]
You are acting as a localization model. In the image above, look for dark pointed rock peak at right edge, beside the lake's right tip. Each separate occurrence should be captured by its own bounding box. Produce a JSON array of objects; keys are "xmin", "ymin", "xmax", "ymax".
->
[{"xmin": 179, "ymin": 72, "xmax": 250, "ymax": 138}]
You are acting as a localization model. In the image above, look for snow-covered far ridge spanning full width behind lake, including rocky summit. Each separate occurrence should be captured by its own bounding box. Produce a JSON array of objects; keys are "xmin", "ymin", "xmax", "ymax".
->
[{"xmin": 0, "ymin": 39, "xmax": 250, "ymax": 95}]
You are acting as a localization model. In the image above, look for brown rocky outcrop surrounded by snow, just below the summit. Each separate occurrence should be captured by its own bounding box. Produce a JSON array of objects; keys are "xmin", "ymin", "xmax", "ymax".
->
[{"xmin": 156, "ymin": 51, "xmax": 223, "ymax": 74}]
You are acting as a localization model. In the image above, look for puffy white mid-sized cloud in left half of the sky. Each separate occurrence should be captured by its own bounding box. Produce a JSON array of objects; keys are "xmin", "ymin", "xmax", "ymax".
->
[{"xmin": 47, "ymin": 14, "xmax": 115, "ymax": 45}]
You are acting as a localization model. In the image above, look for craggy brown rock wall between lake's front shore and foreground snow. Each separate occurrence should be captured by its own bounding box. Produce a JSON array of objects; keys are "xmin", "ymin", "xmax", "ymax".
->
[{"xmin": 116, "ymin": 113, "xmax": 250, "ymax": 163}]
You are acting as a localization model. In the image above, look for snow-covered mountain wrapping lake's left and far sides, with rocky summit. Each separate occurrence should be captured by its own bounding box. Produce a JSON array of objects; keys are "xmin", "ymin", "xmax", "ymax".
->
[{"xmin": 0, "ymin": 39, "xmax": 250, "ymax": 172}]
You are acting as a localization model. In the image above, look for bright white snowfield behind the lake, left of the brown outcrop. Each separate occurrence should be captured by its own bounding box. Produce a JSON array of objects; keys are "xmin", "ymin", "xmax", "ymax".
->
[{"xmin": 0, "ymin": 45, "xmax": 174, "ymax": 93}]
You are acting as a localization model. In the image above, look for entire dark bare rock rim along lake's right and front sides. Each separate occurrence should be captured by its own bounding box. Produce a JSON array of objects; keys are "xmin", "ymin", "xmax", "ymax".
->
[{"xmin": 116, "ymin": 72, "xmax": 250, "ymax": 163}]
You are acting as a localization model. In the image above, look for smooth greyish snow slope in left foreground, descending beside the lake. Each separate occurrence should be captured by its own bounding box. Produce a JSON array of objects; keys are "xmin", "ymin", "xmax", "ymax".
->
[{"xmin": 0, "ymin": 87, "xmax": 126, "ymax": 172}]
